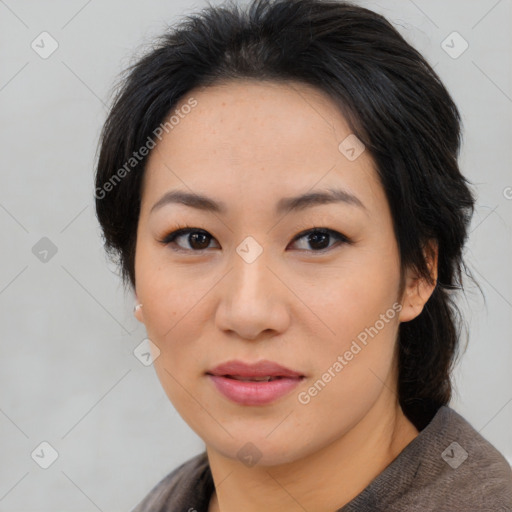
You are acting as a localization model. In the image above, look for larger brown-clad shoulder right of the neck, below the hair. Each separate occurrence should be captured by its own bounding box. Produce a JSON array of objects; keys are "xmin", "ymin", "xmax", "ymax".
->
[{"xmin": 340, "ymin": 406, "xmax": 512, "ymax": 512}]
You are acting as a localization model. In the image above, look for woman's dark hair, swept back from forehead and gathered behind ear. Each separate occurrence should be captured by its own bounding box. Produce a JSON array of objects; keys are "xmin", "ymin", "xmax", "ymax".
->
[{"xmin": 95, "ymin": 0, "xmax": 474, "ymax": 429}]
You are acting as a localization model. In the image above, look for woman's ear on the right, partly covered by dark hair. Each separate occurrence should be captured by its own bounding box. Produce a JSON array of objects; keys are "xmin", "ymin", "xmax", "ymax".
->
[{"xmin": 399, "ymin": 240, "xmax": 438, "ymax": 322}]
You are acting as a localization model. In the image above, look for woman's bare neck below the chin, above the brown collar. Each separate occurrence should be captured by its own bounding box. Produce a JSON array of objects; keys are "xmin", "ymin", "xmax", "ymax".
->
[{"xmin": 207, "ymin": 391, "xmax": 418, "ymax": 512}]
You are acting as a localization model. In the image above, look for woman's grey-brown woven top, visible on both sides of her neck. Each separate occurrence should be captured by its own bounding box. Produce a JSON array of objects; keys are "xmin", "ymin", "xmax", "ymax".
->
[{"xmin": 132, "ymin": 406, "xmax": 512, "ymax": 512}]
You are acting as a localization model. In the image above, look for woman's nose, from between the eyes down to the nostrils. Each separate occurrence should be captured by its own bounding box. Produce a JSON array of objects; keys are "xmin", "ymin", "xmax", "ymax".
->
[{"xmin": 216, "ymin": 246, "xmax": 293, "ymax": 340}]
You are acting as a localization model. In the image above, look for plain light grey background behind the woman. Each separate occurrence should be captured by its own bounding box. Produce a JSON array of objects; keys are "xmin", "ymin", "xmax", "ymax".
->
[{"xmin": 0, "ymin": 0, "xmax": 512, "ymax": 512}]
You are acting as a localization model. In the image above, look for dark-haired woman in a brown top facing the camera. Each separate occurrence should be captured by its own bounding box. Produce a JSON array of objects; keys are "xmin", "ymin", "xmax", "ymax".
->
[{"xmin": 95, "ymin": 0, "xmax": 512, "ymax": 512}]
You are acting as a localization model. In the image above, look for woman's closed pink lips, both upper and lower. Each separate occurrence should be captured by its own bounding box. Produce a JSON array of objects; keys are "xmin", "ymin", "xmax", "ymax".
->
[{"xmin": 207, "ymin": 361, "xmax": 304, "ymax": 405}]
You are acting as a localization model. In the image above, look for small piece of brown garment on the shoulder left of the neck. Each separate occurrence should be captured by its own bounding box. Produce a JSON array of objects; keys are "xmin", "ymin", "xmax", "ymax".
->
[{"xmin": 132, "ymin": 452, "xmax": 213, "ymax": 512}]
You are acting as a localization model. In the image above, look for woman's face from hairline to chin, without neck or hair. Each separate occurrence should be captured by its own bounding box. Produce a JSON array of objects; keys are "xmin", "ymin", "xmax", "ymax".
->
[{"xmin": 135, "ymin": 82, "xmax": 426, "ymax": 465}]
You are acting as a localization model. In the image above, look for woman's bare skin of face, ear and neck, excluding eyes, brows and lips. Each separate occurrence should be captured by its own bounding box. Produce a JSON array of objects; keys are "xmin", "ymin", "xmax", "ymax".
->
[{"xmin": 135, "ymin": 81, "xmax": 437, "ymax": 512}]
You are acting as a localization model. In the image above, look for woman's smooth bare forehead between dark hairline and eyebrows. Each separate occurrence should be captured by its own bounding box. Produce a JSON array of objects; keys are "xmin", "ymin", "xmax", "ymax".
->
[{"xmin": 143, "ymin": 81, "xmax": 379, "ymax": 214}]
